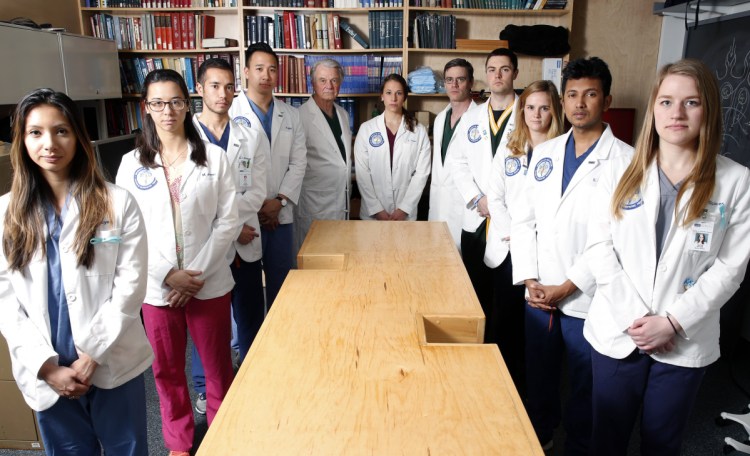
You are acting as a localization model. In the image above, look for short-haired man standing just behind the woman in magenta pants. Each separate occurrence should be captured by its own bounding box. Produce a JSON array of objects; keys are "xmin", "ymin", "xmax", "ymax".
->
[{"xmin": 192, "ymin": 59, "xmax": 266, "ymax": 413}]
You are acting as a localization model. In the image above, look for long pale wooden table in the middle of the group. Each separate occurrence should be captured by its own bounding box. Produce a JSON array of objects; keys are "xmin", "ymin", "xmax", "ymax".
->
[{"xmin": 198, "ymin": 221, "xmax": 542, "ymax": 456}]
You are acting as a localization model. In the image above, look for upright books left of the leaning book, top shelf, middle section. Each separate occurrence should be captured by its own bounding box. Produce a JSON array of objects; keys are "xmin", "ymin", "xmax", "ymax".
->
[{"xmin": 245, "ymin": 11, "xmax": 341, "ymax": 49}]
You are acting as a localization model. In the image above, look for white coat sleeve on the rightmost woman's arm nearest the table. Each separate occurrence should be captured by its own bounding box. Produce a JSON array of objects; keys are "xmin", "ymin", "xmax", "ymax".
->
[{"xmin": 576, "ymin": 162, "xmax": 649, "ymax": 331}]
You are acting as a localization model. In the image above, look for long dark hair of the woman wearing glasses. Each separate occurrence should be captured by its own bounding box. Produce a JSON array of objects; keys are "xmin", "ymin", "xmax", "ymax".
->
[{"xmin": 135, "ymin": 70, "xmax": 207, "ymax": 168}]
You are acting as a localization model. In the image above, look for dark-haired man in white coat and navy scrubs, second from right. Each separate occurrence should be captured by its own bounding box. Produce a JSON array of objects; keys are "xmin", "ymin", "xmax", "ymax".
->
[{"xmin": 510, "ymin": 57, "xmax": 633, "ymax": 455}]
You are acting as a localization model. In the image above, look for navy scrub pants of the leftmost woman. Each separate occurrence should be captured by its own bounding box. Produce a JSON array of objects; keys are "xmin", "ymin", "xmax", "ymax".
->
[{"xmin": 36, "ymin": 374, "xmax": 148, "ymax": 456}]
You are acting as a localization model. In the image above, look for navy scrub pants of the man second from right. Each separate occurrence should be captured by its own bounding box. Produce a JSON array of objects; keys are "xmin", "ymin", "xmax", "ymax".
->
[{"xmin": 525, "ymin": 305, "xmax": 591, "ymax": 455}]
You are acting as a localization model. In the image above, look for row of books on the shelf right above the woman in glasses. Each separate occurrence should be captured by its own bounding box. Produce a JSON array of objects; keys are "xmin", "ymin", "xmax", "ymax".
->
[{"xmin": 120, "ymin": 53, "xmax": 242, "ymax": 95}]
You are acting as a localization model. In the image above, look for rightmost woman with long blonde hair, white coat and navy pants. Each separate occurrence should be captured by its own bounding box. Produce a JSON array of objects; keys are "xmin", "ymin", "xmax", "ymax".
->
[{"xmin": 584, "ymin": 60, "xmax": 750, "ymax": 456}]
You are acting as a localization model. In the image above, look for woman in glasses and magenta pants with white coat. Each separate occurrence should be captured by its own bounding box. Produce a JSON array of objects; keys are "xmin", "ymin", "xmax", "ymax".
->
[{"xmin": 117, "ymin": 70, "xmax": 240, "ymax": 456}]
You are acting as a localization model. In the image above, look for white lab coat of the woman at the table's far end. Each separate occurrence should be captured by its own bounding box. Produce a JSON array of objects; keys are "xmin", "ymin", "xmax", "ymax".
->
[{"xmin": 354, "ymin": 114, "xmax": 430, "ymax": 220}]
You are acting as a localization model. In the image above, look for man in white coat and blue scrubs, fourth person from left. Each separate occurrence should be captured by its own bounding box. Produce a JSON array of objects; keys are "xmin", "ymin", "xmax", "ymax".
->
[{"xmin": 229, "ymin": 43, "xmax": 307, "ymax": 309}]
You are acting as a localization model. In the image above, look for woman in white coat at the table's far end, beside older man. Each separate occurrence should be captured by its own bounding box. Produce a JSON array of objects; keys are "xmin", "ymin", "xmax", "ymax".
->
[{"xmin": 354, "ymin": 73, "xmax": 430, "ymax": 220}]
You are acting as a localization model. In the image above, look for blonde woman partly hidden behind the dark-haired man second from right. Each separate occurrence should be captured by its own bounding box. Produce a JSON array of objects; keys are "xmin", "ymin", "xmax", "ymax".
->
[{"xmin": 484, "ymin": 81, "xmax": 563, "ymax": 397}]
